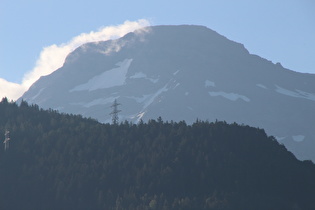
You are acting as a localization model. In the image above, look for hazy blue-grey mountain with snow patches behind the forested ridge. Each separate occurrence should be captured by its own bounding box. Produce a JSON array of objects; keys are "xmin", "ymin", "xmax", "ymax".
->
[{"xmin": 20, "ymin": 25, "xmax": 315, "ymax": 161}]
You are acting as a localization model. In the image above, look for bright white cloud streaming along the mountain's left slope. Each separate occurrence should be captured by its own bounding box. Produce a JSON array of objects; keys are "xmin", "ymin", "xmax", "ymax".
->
[{"xmin": 0, "ymin": 19, "xmax": 150, "ymax": 100}]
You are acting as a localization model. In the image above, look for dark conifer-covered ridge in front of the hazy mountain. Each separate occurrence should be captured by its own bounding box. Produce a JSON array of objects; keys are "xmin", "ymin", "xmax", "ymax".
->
[{"xmin": 0, "ymin": 99, "xmax": 315, "ymax": 210}]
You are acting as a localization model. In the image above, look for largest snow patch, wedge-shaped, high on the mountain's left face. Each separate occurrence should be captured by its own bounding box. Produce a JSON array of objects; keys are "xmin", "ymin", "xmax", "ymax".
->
[{"xmin": 70, "ymin": 59, "xmax": 132, "ymax": 92}]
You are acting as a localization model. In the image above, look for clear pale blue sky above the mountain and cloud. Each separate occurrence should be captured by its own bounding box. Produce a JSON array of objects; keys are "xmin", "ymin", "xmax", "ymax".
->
[{"xmin": 0, "ymin": 0, "xmax": 315, "ymax": 97}]
